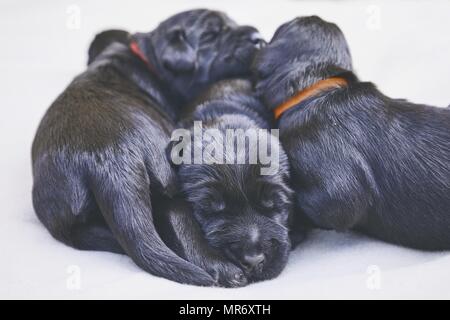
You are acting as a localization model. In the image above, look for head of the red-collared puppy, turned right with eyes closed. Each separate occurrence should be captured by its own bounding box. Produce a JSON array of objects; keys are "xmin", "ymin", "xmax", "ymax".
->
[{"xmin": 134, "ymin": 10, "xmax": 263, "ymax": 99}]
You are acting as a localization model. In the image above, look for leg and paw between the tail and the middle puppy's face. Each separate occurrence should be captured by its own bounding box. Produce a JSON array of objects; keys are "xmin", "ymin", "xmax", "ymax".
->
[{"xmin": 155, "ymin": 199, "xmax": 247, "ymax": 287}]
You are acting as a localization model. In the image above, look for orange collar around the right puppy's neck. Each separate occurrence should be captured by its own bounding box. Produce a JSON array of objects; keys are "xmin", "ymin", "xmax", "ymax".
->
[{"xmin": 273, "ymin": 77, "xmax": 347, "ymax": 119}]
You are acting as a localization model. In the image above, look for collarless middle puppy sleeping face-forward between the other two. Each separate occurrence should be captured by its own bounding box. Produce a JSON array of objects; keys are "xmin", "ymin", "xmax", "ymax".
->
[{"xmin": 169, "ymin": 80, "xmax": 291, "ymax": 281}]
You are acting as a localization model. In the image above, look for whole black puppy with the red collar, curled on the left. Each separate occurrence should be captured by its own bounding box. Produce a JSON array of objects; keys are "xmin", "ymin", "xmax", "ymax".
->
[{"xmin": 32, "ymin": 10, "xmax": 259, "ymax": 285}]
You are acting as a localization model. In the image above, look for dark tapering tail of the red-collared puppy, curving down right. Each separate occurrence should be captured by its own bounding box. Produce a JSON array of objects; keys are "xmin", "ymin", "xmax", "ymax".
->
[{"xmin": 91, "ymin": 163, "xmax": 215, "ymax": 286}]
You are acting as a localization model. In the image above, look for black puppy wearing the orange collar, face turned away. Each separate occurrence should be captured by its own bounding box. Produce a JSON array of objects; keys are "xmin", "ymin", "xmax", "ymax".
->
[{"xmin": 254, "ymin": 16, "xmax": 450, "ymax": 250}]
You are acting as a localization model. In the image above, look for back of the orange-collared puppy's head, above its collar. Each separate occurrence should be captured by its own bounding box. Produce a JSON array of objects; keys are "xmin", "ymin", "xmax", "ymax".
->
[{"xmin": 252, "ymin": 16, "xmax": 352, "ymax": 108}]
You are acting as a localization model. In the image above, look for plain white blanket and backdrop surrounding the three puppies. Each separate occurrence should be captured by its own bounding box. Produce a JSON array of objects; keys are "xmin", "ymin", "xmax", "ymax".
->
[{"xmin": 0, "ymin": 0, "xmax": 450, "ymax": 299}]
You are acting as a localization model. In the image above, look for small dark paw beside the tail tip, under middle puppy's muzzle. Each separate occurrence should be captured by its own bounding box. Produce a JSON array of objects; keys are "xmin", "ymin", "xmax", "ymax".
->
[{"xmin": 206, "ymin": 260, "xmax": 248, "ymax": 288}]
